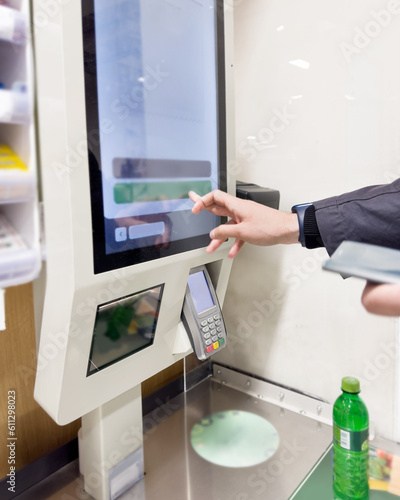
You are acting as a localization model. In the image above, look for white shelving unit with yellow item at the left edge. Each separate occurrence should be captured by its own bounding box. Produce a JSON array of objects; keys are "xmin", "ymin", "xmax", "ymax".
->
[{"xmin": 0, "ymin": 0, "xmax": 41, "ymax": 288}]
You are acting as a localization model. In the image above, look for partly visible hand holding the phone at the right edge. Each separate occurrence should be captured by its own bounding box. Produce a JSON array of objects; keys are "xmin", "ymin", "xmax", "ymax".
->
[{"xmin": 361, "ymin": 281, "xmax": 400, "ymax": 316}]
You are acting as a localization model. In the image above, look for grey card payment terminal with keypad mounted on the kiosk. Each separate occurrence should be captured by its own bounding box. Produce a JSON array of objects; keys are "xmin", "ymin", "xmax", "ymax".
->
[{"xmin": 182, "ymin": 265, "xmax": 226, "ymax": 360}]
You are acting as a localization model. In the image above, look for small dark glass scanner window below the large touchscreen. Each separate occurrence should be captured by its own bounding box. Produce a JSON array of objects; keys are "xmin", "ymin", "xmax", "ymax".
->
[{"xmin": 87, "ymin": 285, "xmax": 164, "ymax": 375}]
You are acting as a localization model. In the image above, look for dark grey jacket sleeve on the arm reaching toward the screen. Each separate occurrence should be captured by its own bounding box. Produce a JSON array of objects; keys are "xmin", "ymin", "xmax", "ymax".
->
[{"xmin": 314, "ymin": 179, "xmax": 400, "ymax": 255}]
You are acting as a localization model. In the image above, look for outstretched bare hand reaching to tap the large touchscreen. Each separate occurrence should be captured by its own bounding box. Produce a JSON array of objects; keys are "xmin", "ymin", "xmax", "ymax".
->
[{"xmin": 189, "ymin": 190, "xmax": 299, "ymax": 258}]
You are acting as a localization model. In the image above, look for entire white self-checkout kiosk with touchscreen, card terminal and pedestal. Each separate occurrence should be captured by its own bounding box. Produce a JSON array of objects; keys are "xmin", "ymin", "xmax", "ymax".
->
[{"xmin": 33, "ymin": 0, "xmax": 235, "ymax": 500}]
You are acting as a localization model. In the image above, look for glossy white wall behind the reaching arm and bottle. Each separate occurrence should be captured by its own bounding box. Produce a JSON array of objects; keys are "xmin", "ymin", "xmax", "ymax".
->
[{"xmin": 218, "ymin": 0, "xmax": 400, "ymax": 438}]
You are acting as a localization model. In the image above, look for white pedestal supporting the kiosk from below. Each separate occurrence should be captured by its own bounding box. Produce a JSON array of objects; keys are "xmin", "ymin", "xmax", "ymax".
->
[{"xmin": 78, "ymin": 385, "xmax": 143, "ymax": 500}]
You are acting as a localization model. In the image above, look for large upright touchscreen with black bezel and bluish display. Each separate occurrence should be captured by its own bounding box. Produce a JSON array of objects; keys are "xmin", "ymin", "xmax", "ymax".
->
[{"xmin": 82, "ymin": 0, "xmax": 226, "ymax": 273}]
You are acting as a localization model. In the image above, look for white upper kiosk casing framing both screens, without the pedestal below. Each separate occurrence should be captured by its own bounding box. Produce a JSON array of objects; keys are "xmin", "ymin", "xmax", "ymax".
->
[{"xmin": 33, "ymin": 0, "xmax": 235, "ymax": 425}]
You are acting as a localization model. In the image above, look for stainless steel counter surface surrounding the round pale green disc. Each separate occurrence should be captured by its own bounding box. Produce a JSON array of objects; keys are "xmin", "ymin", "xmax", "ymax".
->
[{"xmin": 19, "ymin": 379, "xmax": 331, "ymax": 500}]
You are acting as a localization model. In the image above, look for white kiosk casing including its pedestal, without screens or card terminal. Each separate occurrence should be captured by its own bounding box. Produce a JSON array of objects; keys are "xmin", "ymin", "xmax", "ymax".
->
[{"xmin": 33, "ymin": 0, "xmax": 236, "ymax": 500}]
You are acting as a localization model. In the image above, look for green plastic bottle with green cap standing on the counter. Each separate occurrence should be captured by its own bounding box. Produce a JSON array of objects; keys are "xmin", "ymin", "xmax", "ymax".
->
[{"xmin": 333, "ymin": 377, "xmax": 369, "ymax": 500}]
